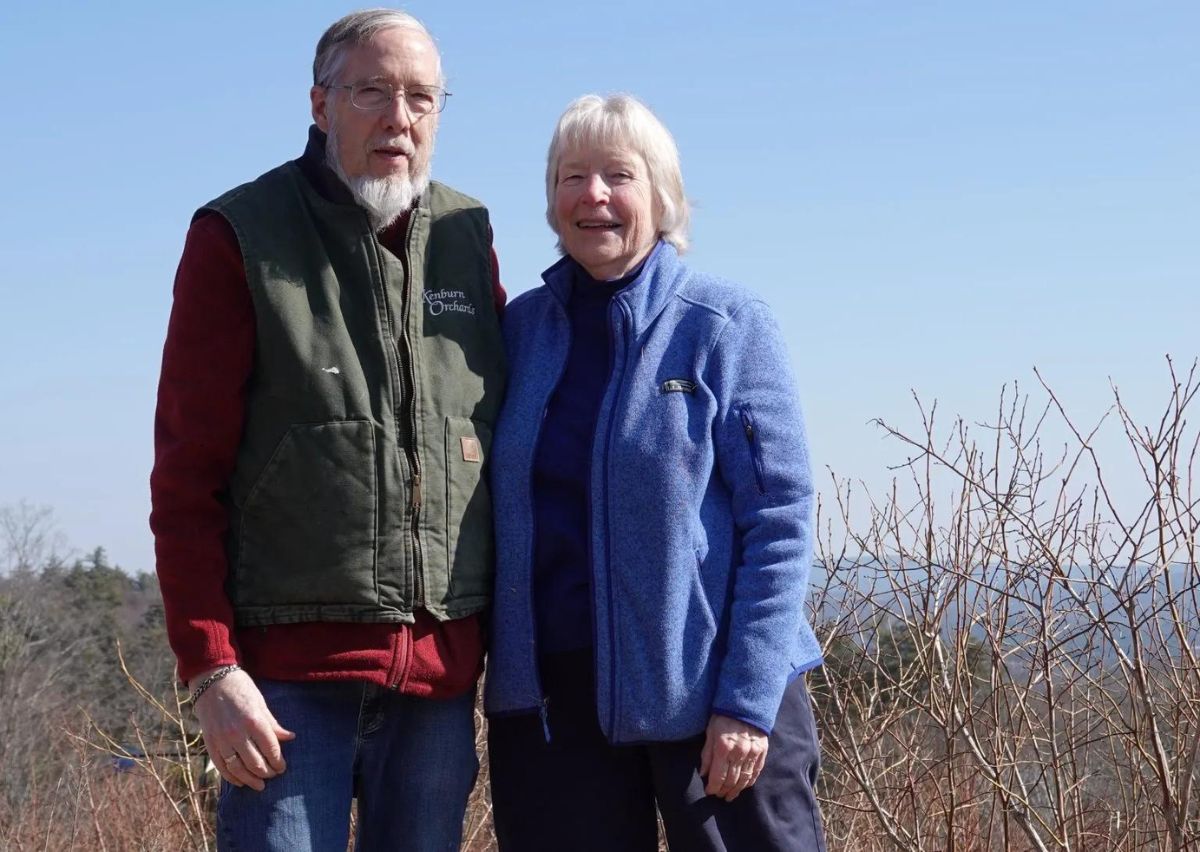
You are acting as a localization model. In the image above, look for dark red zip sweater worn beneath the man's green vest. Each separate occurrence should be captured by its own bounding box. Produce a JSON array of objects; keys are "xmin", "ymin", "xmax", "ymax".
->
[{"xmin": 150, "ymin": 215, "xmax": 505, "ymax": 698}]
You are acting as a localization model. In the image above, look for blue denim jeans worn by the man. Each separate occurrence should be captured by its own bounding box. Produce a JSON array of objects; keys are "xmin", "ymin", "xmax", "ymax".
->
[{"xmin": 217, "ymin": 680, "xmax": 479, "ymax": 852}]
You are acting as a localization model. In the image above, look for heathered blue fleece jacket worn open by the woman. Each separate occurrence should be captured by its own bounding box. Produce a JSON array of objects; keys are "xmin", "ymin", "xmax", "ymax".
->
[{"xmin": 485, "ymin": 242, "xmax": 821, "ymax": 743}]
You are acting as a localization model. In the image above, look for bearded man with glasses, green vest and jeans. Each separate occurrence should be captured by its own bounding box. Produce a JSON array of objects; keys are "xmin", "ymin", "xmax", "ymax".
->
[{"xmin": 151, "ymin": 10, "xmax": 504, "ymax": 850}]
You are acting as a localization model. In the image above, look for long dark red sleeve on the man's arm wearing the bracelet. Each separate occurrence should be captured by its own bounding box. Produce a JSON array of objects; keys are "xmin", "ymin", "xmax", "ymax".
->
[{"xmin": 150, "ymin": 215, "xmax": 254, "ymax": 682}]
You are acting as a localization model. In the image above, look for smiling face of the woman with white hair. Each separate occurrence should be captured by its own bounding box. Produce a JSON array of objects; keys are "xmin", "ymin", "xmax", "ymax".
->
[{"xmin": 554, "ymin": 146, "xmax": 659, "ymax": 281}]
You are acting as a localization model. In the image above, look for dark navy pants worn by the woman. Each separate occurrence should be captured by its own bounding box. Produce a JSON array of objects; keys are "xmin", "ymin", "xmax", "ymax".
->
[{"xmin": 487, "ymin": 652, "xmax": 826, "ymax": 852}]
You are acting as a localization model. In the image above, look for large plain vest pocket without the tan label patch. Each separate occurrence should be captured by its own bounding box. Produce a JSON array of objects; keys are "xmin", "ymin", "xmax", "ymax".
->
[{"xmin": 233, "ymin": 420, "xmax": 378, "ymax": 606}]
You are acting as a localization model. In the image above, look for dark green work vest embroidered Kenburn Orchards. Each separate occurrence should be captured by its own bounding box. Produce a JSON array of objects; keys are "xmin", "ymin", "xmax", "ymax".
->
[{"xmin": 204, "ymin": 162, "xmax": 505, "ymax": 625}]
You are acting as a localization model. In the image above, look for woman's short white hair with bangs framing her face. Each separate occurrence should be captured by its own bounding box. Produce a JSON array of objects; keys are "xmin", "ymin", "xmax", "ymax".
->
[{"xmin": 546, "ymin": 94, "xmax": 691, "ymax": 253}]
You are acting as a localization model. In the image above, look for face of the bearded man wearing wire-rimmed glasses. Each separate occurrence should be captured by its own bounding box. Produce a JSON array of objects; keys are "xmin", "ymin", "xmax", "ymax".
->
[{"xmin": 311, "ymin": 28, "xmax": 440, "ymax": 180}]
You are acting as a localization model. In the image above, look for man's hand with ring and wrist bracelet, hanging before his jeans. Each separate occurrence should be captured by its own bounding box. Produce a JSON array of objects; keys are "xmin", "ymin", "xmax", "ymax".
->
[{"xmin": 190, "ymin": 668, "xmax": 295, "ymax": 792}]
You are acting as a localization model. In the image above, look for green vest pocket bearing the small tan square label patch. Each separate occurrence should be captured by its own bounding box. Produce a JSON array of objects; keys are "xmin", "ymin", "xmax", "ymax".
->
[{"xmin": 445, "ymin": 416, "xmax": 496, "ymax": 602}]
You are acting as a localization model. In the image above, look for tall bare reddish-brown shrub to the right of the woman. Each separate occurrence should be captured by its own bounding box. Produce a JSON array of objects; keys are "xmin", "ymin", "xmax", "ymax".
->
[{"xmin": 814, "ymin": 366, "xmax": 1200, "ymax": 850}]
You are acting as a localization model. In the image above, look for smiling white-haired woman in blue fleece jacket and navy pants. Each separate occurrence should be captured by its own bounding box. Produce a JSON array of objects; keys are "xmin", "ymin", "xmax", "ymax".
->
[{"xmin": 486, "ymin": 95, "xmax": 823, "ymax": 852}]
